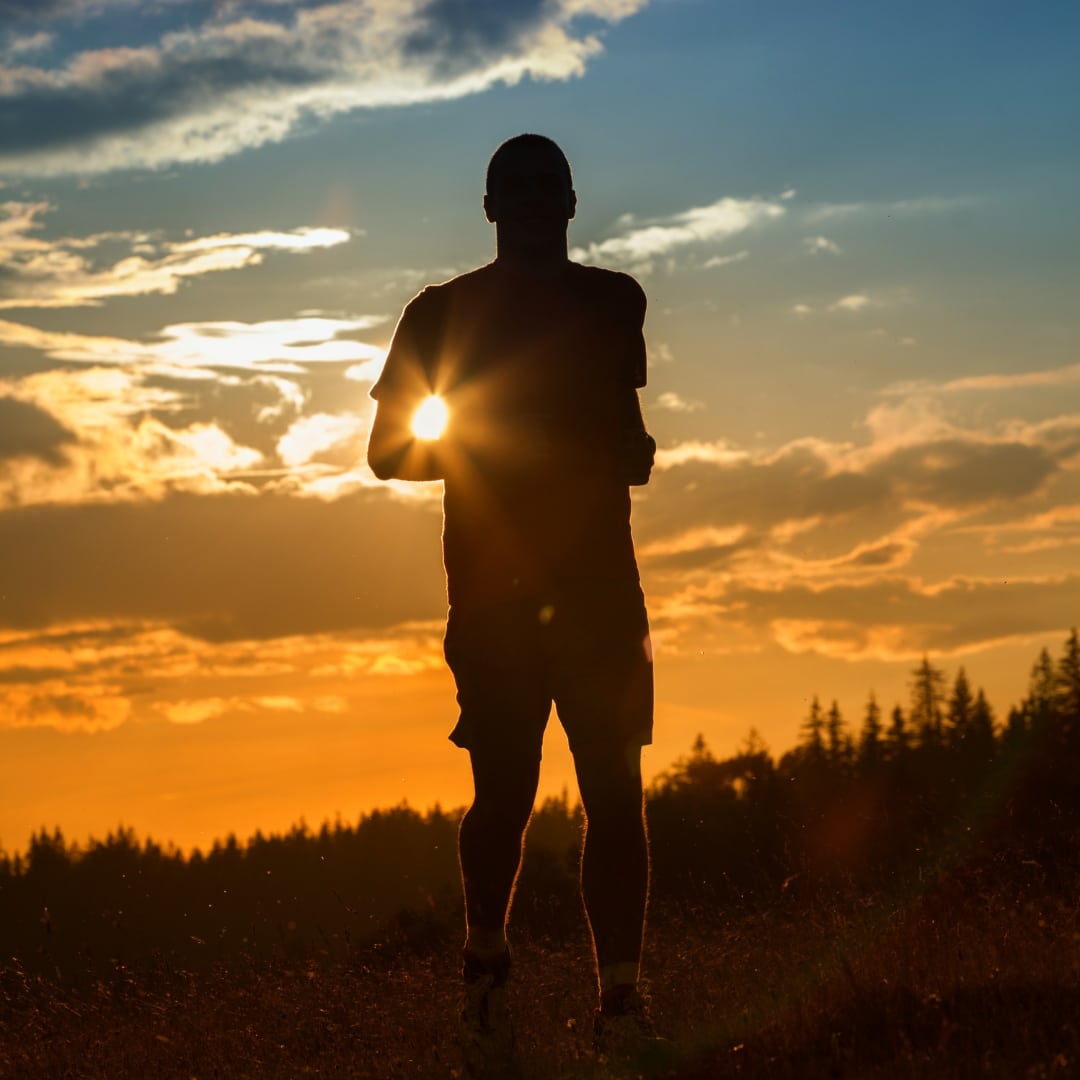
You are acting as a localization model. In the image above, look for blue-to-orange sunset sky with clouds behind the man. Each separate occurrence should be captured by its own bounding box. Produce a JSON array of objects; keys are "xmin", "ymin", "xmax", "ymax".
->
[{"xmin": 0, "ymin": 0, "xmax": 1080, "ymax": 851}]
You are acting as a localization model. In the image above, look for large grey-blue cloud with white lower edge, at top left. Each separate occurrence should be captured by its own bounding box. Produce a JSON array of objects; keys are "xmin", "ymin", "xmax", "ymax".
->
[{"xmin": 0, "ymin": 0, "xmax": 645, "ymax": 175}]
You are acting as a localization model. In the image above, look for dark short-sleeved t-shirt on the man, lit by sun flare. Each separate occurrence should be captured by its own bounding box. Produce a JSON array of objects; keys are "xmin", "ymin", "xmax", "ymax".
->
[{"xmin": 372, "ymin": 255, "xmax": 646, "ymax": 605}]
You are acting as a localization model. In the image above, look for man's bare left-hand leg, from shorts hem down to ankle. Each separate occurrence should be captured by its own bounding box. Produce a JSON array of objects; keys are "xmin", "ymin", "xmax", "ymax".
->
[{"xmin": 458, "ymin": 750, "xmax": 540, "ymax": 960}]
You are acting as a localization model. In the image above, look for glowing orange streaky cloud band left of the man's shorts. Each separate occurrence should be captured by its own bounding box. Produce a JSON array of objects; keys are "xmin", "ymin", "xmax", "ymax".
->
[{"xmin": 0, "ymin": 620, "xmax": 443, "ymax": 732}]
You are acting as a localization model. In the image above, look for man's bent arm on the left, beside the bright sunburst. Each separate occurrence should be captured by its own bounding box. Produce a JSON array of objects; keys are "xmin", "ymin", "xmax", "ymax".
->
[{"xmin": 367, "ymin": 294, "xmax": 443, "ymax": 481}]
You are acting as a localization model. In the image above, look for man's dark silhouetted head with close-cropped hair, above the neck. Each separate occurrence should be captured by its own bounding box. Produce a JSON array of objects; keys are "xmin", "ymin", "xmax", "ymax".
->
[{"xmin": 484, "ymin": 147, "xmax": 576, "ymax": 234}]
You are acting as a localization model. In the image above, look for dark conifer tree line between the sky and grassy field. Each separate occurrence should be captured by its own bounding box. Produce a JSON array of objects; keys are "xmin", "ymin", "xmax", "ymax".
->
[{"xmin": 0, "ymin": 630, "xmax": 1080, "ymax": 977}]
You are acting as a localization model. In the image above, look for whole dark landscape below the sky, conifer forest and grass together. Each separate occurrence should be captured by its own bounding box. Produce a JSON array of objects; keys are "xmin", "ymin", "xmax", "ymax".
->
[{"xmin": 0, "ymin": 630, "xmax": 1080, "ymax": 1080}]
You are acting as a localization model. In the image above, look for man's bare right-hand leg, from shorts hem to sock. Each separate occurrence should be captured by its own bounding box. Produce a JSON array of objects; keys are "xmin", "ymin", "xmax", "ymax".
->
[{"xmin": 573, "ymin": 745, "xmax": 649, "ymax": 994}]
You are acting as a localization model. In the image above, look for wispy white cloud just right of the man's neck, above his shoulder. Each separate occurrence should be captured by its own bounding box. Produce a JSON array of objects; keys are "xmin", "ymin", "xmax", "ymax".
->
[{"xmin": 571, "ymin": 198, "xmax": 786, "ymax": 272}]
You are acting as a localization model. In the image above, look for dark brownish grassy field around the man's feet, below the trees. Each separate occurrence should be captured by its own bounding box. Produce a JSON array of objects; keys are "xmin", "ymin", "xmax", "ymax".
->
[{"xmin": 0, "ymin": 866, "xmax": 1080, "ymax": 1080}]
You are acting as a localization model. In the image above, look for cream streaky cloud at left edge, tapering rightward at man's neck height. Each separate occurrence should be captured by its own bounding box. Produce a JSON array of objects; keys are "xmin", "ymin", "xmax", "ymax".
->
[{"xmin": 0, "ymin": 201, "xmax": 351, "ymax": 309}]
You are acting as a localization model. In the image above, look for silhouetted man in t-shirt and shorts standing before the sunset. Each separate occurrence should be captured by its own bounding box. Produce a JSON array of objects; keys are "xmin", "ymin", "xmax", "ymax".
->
[{"xmin": 368, "ymin": 134, "xmax": 656, "ymax": 1075}]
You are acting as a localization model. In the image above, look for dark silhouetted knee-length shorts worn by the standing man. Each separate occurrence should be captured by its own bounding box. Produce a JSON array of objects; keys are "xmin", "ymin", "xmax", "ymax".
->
[{"xmin": 444, "ymin": 582, "xmax": 652, "ymax": 760}]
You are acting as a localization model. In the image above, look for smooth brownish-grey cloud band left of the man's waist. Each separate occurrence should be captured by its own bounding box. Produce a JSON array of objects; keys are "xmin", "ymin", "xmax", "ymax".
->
[{"xmin": 0, "ymin": 494, "xmax": 445, "ymax": 640}]
